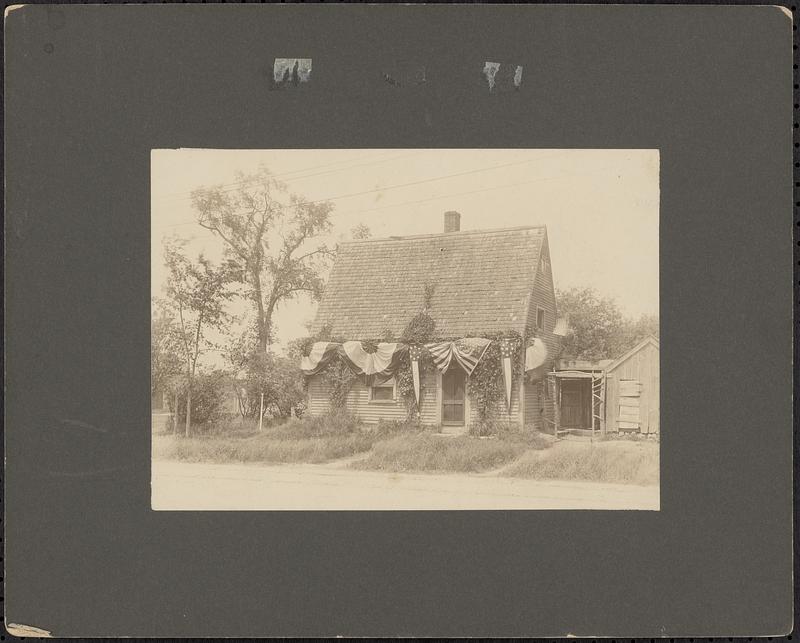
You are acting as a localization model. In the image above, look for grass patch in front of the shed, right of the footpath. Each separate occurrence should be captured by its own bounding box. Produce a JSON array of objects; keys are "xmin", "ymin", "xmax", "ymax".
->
[{"xmin": 503, "ymin": 442, "xmax": 658, "ymax": 485}]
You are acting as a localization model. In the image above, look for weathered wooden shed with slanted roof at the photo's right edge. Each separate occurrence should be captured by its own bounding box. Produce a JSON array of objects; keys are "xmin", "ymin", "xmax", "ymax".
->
[{"xmin": 606, "ymin": 336, "xmax": 659, "ymax": 434}]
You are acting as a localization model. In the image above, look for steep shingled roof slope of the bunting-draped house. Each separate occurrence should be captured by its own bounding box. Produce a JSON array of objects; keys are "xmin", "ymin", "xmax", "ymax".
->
[{"xmin": 311, "ymin": 226, "xmax": 547, "ymax": 340}]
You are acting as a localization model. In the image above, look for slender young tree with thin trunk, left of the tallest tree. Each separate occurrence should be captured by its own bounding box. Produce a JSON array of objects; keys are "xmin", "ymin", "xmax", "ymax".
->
[{"xmin": 164, "ymin": 240, "xmax": 232, "ymax": 437}]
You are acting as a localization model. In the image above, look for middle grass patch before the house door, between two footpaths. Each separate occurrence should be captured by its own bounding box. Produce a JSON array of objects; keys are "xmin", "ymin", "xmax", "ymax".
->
[{"xmin": 350, "ymin": 433, "xmax": 530, "ymax": 472}]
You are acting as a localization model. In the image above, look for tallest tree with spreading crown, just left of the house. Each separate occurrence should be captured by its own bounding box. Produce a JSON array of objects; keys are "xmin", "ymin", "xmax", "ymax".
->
[{"xmin": 191, "ymin": 167, "xmax": 333, "ymax": 352}]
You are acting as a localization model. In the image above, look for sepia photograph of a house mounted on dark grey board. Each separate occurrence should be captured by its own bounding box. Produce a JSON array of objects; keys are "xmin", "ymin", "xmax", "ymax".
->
[{"xmin": 151, "ymin": 148, "xmax": 656, "ymax": 511}]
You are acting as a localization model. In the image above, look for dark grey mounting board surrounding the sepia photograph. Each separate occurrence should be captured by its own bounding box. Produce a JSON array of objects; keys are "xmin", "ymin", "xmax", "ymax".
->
[{"xmin": 4, "ymin": 5, "xmax": 792, "ymax": 637}]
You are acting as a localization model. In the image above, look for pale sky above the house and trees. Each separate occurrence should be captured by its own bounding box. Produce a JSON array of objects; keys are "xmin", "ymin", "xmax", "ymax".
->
[{"xmin": 151, "ymin": 149, "xmax": 659, "ymax": 364}]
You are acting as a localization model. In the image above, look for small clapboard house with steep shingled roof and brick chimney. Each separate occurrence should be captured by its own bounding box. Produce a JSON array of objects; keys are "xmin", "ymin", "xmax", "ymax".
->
[{"xmin": 307, "ymin": 212, "xmax": 561, "ymax": 433}]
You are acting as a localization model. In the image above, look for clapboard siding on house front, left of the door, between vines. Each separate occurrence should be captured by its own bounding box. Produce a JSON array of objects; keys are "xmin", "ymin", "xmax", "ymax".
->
[{"xmin": 308, "ymin": 373, "xmax": 439, "ymax": 424}]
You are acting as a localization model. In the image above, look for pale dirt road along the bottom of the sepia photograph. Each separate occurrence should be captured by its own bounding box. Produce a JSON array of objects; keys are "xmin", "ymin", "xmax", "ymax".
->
[{"xmin": 152, "ymin": 460, "xmax": 659, "ymax": 511}]
